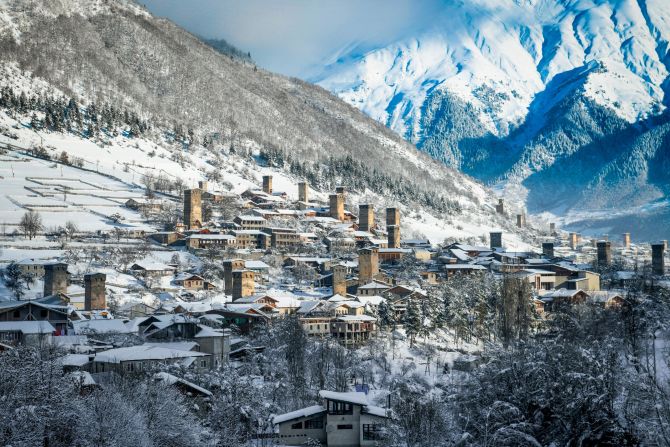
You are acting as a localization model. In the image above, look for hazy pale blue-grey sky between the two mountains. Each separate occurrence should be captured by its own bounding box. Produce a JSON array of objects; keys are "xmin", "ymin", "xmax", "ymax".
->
[{"xmin": 139, "ymin": 0, "xmax": 444, "ymax": 78}]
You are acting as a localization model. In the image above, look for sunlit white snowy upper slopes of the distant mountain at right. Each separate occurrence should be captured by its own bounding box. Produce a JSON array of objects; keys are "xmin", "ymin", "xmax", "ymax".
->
[{"xmin": 315, "ymin": 0, "xmax": 670, "ymax": 142}]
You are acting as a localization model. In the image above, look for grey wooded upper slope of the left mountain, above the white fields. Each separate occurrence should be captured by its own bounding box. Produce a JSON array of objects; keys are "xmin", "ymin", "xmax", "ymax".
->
[{"xmin": 0, "ymin": 0, "xmax": 532, "ymax": 248}]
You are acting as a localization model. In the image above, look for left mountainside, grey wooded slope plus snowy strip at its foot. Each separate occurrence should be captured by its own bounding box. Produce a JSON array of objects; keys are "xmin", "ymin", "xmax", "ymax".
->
[{"xmin": 0, "ymin": 0, "xmax": 533, "ymax": 247}]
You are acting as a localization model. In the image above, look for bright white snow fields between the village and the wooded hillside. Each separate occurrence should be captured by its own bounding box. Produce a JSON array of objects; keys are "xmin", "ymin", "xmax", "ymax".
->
[{"xmin": 0, "ymin": 106, "xmax": 529, "ymax": 250}]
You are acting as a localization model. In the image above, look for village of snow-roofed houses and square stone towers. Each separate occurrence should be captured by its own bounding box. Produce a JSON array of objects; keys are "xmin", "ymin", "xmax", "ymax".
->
[{"xmin": 0, "ymin": 166, "xmax": 667, "ymax": 446}]
